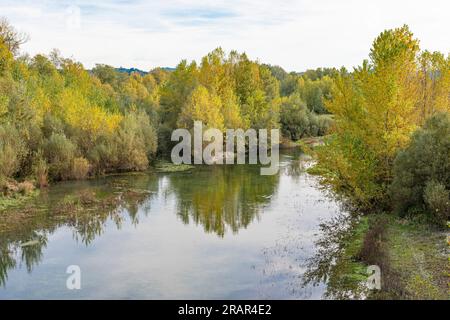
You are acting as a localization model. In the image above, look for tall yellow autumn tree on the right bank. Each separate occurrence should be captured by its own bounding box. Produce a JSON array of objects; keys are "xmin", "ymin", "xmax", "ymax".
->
[{"xmin": 318, "ymin": 26, "xmax": 448, "ymax": 207}]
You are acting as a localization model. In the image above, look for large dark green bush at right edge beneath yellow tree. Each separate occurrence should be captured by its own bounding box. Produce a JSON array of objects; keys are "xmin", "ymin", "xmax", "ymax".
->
[{"xmin": 390, "ymin": 113, "xmax": 450, "ymax": 220}]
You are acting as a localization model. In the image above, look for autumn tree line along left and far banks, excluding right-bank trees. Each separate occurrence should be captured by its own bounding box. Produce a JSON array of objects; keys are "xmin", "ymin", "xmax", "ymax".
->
[{"xmin": 0, "ymin": 19, "xmax": 331, "ymax": 194}]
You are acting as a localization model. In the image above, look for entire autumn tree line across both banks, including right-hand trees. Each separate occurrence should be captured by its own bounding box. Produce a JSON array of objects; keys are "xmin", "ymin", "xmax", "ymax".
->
[{"xmin": 0, "ymin": 20, "xmax": 450, "ymax": 221}]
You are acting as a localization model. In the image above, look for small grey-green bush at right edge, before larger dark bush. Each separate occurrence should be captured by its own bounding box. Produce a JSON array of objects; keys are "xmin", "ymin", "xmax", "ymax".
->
[{"xmin": 424, "ymin": 180, "xmax": 450, "ymax": 224}]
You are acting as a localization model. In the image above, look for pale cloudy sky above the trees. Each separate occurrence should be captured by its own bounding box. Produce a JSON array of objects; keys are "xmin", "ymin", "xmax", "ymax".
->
[{"xmin": 0, "ymin": 0, "xmax": 450, "ymax": 71}]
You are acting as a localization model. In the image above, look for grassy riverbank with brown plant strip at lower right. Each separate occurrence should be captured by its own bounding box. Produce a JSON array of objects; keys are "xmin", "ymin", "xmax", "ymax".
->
[{"xmin": 329, "ymin": 214, "xmax": 449, "ymax": 300}]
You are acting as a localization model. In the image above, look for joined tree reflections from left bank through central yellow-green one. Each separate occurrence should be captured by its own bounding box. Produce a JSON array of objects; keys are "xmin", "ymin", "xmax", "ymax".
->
[{"xmin": 0, "ymin": 165, "xmax": 279, "ymax": 285}]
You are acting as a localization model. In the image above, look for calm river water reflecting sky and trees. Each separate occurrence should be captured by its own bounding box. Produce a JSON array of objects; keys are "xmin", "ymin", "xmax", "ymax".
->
[{"xmin": 0, "ymin": 151, "xmax": 348, "ymax": 299}]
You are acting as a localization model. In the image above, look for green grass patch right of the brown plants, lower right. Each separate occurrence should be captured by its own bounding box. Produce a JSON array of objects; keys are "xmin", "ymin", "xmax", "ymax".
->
[{"xmin": 380, "ymin": 217, "xmax": 449, "ymax": 299}]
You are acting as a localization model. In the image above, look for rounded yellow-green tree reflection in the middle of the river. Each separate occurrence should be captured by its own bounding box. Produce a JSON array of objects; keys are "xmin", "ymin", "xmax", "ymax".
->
[{"xmin": 168, "ymin": 165, "xmax": 279, "ymax": 237}]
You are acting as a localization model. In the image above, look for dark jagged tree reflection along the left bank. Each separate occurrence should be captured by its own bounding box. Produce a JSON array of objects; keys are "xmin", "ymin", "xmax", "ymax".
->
[{"xmin": 0, "ymin": 174, "xmax": 158, "ymax": 286}]
